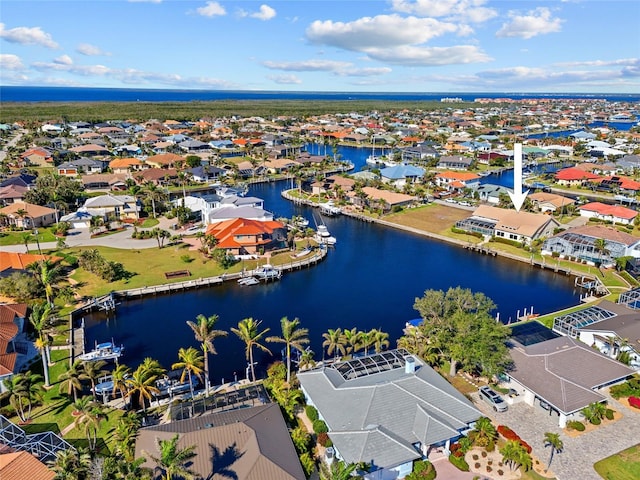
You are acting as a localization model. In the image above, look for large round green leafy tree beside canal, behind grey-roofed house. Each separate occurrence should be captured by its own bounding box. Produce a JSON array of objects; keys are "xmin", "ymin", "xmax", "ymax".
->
[{"xmin": 399, "ymin": 287, "xmax": 510, "ymax": 376}]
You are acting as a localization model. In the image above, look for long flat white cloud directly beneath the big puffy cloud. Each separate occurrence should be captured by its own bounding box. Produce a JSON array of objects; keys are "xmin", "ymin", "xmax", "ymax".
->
[{"xmin": 367, "ymin": 45, "xmax": 492, "ymax": 66}]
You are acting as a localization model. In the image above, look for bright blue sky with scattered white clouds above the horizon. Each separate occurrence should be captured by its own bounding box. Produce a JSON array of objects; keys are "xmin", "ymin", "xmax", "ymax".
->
[{"xmin": 0, "ymin": 0, "xmax": 640, "ymax": 93}]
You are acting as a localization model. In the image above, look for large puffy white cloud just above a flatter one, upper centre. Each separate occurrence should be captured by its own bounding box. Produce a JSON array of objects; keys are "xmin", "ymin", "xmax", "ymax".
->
[{"xmin": 306, "ymin": 14, "xmax": 459, "ymax": 51}]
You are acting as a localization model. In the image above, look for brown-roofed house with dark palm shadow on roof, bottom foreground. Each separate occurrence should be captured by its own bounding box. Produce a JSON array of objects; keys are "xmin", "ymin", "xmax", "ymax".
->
[{"xmin": 136, "ymin": 403, "xmax": 306, "ymax": 480}]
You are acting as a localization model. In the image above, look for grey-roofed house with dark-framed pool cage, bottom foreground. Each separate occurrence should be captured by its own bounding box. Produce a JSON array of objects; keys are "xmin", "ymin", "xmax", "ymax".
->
[{"xmin": 298, "ymin": 349, "xmax": 481, "ymax": 479}]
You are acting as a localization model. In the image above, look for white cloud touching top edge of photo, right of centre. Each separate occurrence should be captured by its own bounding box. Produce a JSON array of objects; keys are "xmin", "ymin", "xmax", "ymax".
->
[{"xmin": 392, "ymin": 0, "xmax": 498, "ymax": 23}]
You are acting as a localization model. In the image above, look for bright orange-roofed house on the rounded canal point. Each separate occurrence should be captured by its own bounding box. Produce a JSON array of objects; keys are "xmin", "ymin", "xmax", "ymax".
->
[{"xmin": 206, "ymin": 218, "xmax": 287, "ymax": 255}]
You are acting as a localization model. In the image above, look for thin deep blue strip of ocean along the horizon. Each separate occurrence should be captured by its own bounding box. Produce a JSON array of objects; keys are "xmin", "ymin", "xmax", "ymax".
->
[{"xmin": 0, "ymin": 86, "xmax": 640, "ymax": 103}]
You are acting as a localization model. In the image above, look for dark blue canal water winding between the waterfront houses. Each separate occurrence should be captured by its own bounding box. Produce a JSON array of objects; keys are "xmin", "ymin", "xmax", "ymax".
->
[{"xmin": 85, "ymin": 144, "xmax": 581, "ymax": 384}]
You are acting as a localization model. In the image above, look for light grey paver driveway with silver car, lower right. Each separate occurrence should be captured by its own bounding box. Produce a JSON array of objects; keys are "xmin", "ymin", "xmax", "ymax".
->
[{"xmin": 473, "ymin": 394, "xmax": 640, "ymax": 480}]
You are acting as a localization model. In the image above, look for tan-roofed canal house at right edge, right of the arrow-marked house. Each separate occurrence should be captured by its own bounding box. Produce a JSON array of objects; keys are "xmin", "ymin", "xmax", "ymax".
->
[{"xmin": 542, "ymin": 225, "xmax": 640, "ymax": 265}]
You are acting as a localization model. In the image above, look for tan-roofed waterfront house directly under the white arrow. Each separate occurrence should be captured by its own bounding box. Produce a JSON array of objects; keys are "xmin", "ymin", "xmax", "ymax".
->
[{"xmin": 456, "ymin": 205, "xmax": 560, "ymax": 245}]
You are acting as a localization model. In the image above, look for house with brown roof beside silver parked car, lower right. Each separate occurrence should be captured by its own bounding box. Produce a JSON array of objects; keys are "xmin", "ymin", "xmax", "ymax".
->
[{"xmin": 508, "ymin": 336, "xmax": 634, "ymax": 428}]
